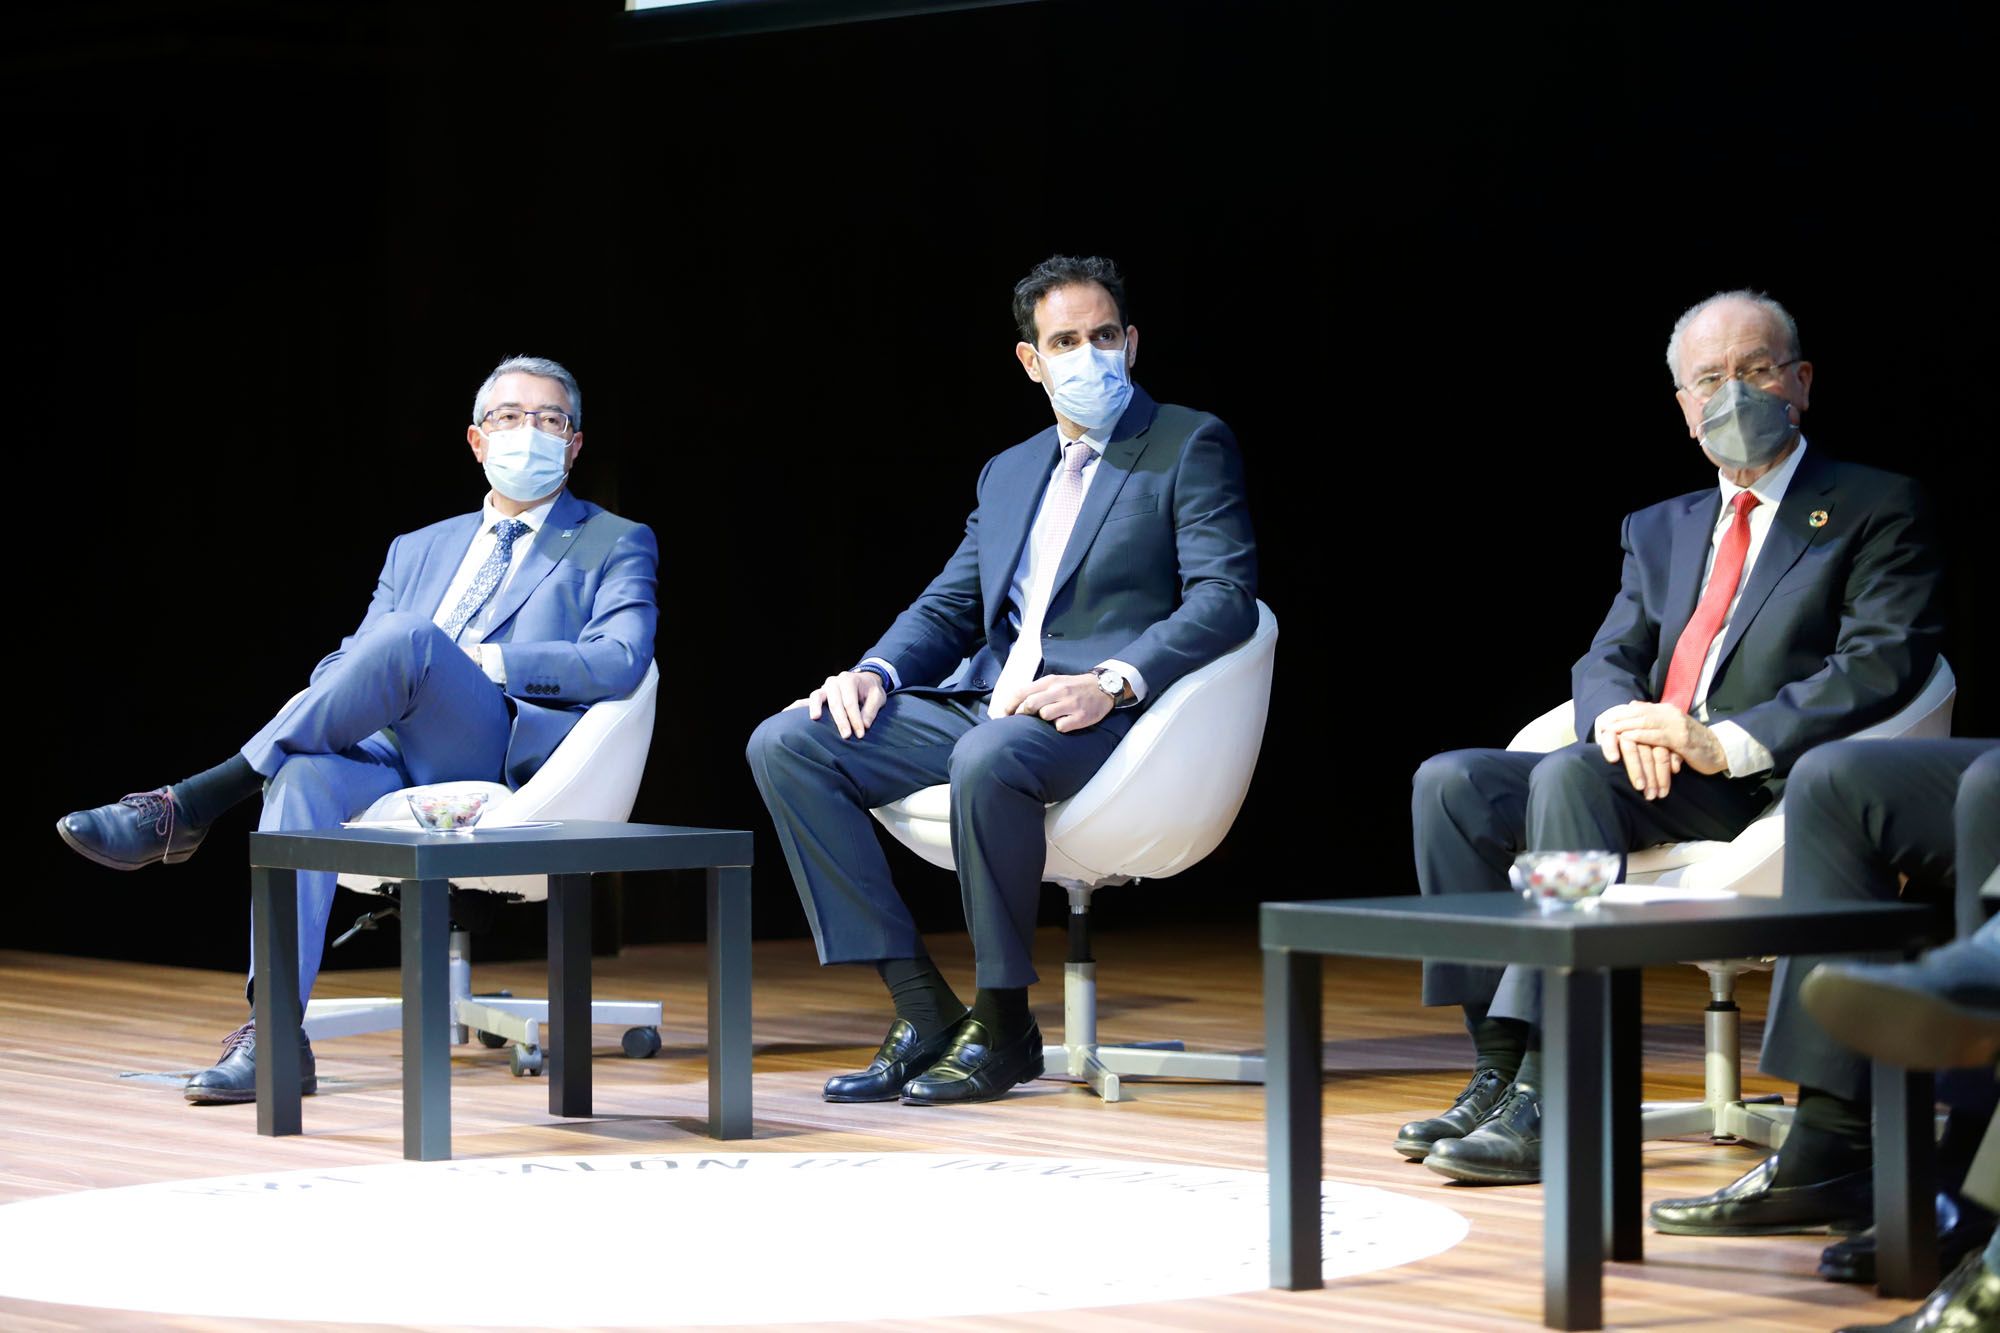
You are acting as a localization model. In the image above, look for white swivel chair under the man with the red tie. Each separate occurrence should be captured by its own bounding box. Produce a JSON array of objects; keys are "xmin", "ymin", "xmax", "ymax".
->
[{"xmin": 1508, "ymin": 656, "xmax": 1958, "ymax": 1149}]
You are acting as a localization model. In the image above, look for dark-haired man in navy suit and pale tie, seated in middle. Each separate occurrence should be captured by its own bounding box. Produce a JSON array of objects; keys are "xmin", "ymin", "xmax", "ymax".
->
[{"xmin": 748, "ymin": 256, "xmax": 1256, "ymax": 1105}]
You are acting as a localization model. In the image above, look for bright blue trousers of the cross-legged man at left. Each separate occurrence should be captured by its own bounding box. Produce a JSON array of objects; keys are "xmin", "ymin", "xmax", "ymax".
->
[{"xmin": 242, "ymin": 610, "xmax": 514, "ymax": 1003}]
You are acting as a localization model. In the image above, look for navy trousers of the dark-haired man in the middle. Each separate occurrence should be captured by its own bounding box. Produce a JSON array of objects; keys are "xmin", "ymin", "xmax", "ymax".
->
[{"xmin": 748, "ymin": 693, "xmax": 1134, "ymax": 987}]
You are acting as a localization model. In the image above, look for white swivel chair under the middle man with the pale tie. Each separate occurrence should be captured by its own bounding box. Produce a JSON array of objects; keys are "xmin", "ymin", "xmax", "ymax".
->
[{"xmin": 874, "ymin": 602, "xmax": 1278, "ymax": 1101}]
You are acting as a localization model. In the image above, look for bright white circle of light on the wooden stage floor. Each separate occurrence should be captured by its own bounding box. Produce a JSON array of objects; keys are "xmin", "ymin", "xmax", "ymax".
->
[{"xmin": 0, "ymin": 1151, "xmax": 1466, "ymax": 1327}]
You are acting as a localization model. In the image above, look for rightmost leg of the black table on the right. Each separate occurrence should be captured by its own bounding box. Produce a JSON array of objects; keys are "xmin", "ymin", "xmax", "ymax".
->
[{"xmin": 1874, "ymin": 1061, "xmax": 1938, "ymax": 1299}]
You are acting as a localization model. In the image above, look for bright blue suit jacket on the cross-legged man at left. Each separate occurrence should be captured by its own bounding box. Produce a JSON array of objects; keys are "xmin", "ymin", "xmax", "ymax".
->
[{"xmin": 312, "ymin": 490, "xmax": 660, "ymax": 787}]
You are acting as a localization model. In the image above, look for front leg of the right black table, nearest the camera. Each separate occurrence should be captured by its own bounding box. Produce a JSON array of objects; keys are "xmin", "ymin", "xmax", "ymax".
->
[{"xmin": 1542, "ymin": 967, "xmax": 1606, "ymax": 1329}]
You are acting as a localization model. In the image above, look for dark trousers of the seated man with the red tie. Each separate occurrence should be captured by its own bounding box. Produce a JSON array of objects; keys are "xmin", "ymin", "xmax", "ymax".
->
[{"xmin": 1410, "ymin": 741, "xmax": 1770, "ymax": 1023}]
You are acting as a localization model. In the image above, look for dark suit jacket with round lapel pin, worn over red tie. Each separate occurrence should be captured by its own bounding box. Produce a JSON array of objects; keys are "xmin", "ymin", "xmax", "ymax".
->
[{"xmin": 1570, "ymin": 448, "xmax": 1942, "ymax": 781}]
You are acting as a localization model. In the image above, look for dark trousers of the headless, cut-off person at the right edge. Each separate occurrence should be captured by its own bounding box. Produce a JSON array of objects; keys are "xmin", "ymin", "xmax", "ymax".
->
[{"xmin": 1760, "ymin": 739, "xmax": 2000, "ymax": 1099}]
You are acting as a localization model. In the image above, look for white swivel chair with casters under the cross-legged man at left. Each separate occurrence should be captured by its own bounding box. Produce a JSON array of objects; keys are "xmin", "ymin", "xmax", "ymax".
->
[{"xmin": 306, "ymin": 664, "xmax": 662, "ymax": 1077}]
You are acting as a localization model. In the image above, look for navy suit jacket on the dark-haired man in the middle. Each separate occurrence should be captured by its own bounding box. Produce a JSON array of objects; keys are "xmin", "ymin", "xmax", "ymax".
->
[{"xmin": 866, "ymin": 388, "xmax": 1256, "ymax": 701}]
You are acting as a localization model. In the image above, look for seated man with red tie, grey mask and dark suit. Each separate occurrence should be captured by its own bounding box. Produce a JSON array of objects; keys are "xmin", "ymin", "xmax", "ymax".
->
[{"xmin": 1396, "ymin": 292, "xmax": 1940, "ymax": 1185}]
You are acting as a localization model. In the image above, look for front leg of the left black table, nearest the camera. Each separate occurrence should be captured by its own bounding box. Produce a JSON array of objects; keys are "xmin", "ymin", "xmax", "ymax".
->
[{"xmin": 400, "ymin": 879, "xmax": 456, "ymax": 1161}]
